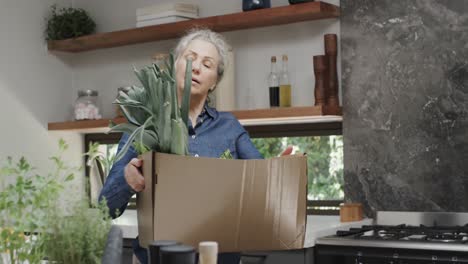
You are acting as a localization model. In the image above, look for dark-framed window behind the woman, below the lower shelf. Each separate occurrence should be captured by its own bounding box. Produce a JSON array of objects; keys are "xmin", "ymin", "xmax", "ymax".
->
[{"xmin": 85, "ymin": 123, "xmax": 344, "ymax": 214}]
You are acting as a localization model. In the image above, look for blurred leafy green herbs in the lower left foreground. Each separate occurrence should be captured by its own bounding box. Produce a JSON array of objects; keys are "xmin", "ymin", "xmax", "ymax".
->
[{"xmin": 0, "ymin": 140, "xmax": 111, "ymax": 264}]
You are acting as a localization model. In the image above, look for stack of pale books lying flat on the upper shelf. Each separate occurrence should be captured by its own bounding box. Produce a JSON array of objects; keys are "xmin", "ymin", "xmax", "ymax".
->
[{"xmin": 136, "ymin": 2, "xmax": 198, "ymax": 27}]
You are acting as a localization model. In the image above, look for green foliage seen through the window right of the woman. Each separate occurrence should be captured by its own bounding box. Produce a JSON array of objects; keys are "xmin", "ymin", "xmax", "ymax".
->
[{"xmin": 252, "ymin": 136, "xmax": 344, "ymax": 200}]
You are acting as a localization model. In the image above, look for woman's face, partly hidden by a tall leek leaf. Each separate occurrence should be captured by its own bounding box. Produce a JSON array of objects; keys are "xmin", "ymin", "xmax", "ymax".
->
[{"xmin": 176, "ymin": 39, "xmax": 219, "ymax": 99}]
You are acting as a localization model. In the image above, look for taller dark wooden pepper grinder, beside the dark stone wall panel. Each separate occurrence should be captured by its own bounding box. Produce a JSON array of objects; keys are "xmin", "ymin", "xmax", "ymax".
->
[{"xmin": 324, "ymin": 34, "xmax": 340, "ymax": 107}]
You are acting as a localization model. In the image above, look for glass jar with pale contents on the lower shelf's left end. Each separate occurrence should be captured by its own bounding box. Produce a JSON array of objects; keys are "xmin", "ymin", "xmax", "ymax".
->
[{"xmin": 74, "ymin": 90, "xmax": 102, "ymax": 120}]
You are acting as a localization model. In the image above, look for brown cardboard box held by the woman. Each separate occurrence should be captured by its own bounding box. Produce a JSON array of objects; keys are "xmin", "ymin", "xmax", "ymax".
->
[{"xmin": 137, "ymin": 152, "xmax": 307, "ymax": 252}]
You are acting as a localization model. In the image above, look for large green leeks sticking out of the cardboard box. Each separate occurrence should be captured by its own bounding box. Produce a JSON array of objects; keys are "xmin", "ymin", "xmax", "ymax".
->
[{"xmin": 110, "ymin": 54, "xmax": 192, "ymax": 160}]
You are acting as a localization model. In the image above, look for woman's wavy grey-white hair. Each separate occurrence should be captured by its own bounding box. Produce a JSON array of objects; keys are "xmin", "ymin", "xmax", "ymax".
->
[{"xmin": 174, "ymin": 29, "xmax": 229, "ymax": 83}]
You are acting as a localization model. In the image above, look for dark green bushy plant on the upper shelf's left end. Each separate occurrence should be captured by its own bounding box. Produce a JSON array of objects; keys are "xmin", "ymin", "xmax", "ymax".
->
[{"xmin": 46, "ymin": 5, "xmax": 96, "ymax": 40}]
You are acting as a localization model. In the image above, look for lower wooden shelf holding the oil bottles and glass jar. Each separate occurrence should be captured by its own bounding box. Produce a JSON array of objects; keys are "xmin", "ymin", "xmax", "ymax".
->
[{"xmin": 48, "ymin": 106, "xmax": 342, "ymax": 132}]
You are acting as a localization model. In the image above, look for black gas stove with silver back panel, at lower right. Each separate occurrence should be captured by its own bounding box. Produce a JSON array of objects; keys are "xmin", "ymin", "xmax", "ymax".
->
[{"xmin": 315, "ymin": 212, "xmax": 468, "ymax": 264}]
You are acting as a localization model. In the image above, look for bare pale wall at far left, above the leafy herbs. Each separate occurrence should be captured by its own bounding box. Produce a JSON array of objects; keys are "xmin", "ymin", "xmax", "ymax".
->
[{"xmin": 0, "ymin": 0, "xmax": 81, "ymax": 194}]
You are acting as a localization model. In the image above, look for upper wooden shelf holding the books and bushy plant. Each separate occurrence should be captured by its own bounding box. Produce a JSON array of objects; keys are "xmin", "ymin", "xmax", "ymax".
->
[{"xmin": 48, "ymin": 1, "xmax": 340, "ymax": 52}]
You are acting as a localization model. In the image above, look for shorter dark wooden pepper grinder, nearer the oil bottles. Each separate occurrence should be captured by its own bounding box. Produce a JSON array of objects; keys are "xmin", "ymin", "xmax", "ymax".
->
[{"xmin": 314, "ymin": 55, "xmax": 328, "ymax": 106}]
